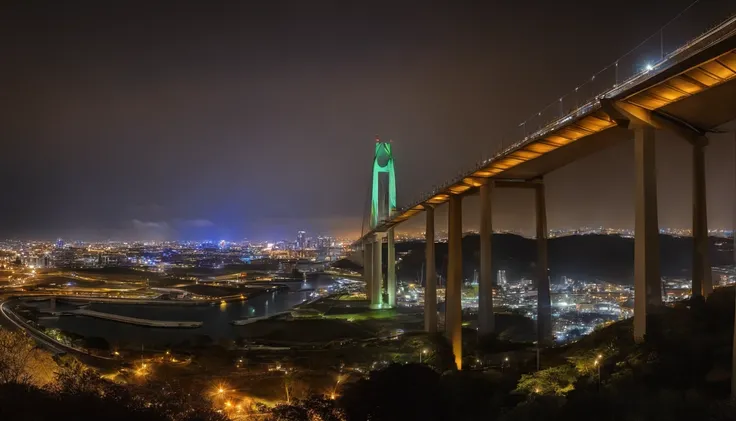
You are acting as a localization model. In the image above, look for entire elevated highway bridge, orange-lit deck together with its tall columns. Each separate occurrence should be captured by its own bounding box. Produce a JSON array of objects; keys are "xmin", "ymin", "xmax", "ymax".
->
[{"xmin": 358, "ymin": 11, "xmax": 736, "ymax": 367}]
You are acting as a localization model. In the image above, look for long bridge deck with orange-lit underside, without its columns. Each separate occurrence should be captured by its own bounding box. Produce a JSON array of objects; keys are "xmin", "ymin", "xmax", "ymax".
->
[{"xmin": 364, "ymin": 16, "xmax": 736, "ymax": 238}]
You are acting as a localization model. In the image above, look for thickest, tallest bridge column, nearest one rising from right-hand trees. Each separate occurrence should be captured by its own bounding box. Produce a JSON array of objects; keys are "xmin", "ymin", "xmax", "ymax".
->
[{"xmin": 634, "ymin": 126, "xmax": 662, "ymax": 341}]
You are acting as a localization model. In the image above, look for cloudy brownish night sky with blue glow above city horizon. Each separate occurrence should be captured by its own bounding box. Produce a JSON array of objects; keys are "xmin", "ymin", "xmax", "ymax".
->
[{"xmin": 0, "ymin": 0, "xmax": 734, "ymax": 240}]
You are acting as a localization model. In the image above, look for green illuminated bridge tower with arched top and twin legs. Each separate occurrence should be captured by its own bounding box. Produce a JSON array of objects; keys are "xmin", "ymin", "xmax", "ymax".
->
[{"xmin": 363, "ymin": 138, "xmax": 396, "ymax": 308}]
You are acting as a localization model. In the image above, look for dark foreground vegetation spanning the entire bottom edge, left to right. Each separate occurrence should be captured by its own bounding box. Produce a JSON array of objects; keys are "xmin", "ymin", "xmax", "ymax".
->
[{"xmin": 0, "ymin": 288, "xmax": 736, "ymax": 421}]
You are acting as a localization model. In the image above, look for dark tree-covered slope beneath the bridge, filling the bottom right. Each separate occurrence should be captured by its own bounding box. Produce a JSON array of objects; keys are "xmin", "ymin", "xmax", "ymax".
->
[{"xmin": 272, "ymin": 288, "xmax": 736, "ymax": 421}]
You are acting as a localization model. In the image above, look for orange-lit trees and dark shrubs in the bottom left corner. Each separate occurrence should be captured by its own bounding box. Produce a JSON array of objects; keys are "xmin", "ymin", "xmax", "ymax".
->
[{"xmin": 0, "ymin": 344, "xmax": 228, "ymax": 421}]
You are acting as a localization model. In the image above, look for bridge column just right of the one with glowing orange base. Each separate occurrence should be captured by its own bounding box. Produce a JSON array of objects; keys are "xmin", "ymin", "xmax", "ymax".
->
[{"xmin": 478, "ymin": 180, "xmax": 495, "ymax": 335}]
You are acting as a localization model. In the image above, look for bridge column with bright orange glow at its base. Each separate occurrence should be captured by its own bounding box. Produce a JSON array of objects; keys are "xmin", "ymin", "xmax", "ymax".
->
[{"xmin": 445, "ymin": 195, "xmax": 463, "ymax": 370}]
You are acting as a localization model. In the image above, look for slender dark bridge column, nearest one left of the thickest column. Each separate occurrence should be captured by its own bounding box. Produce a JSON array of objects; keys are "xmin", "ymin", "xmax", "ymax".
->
[{"xmin": 534, "ymin": 181, "xmax": 552, "ymax": 346}]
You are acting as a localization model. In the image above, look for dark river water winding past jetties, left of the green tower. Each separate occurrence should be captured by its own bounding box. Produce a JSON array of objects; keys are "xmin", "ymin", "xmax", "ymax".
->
[{"xmin": 34, "ymin": 276, "xmax": 333, "ymax": 347}]
